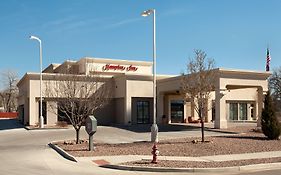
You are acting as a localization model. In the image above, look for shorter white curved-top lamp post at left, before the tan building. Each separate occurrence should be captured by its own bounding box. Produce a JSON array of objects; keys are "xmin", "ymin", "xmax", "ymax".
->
[{"xmin": 29, "ymin": 36, "xmax": 44, "ymax": 128}]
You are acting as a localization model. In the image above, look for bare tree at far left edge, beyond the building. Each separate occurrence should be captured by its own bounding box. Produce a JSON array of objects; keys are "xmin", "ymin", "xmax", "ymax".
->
[{"xmin": 0, "ymin": 70, "xmax": 18, "ymax": 112}]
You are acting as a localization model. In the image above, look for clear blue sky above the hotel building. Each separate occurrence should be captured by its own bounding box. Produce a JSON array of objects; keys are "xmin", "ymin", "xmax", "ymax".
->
[{"xmin": 0, "ymin": 0, "xmax": 281, "ymax": 76}]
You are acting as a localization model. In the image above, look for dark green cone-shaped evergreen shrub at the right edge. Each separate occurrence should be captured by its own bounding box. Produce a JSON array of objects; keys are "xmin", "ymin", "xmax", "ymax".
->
[{"xmin": 261, "ymin": 92, "xmax": 281, "ymax": 140}]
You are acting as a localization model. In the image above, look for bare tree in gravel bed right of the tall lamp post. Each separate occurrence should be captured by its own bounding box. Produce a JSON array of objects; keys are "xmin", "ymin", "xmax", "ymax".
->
[{"xmin": 182, "ymin": 50, "xmax": 215, "ymax": 142}]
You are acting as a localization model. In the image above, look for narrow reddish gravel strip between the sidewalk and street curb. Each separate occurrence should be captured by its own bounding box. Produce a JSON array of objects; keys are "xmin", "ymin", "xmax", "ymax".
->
[{"xmin": 121, "ymin": 157, "xmax": 281, "ymax": 168}]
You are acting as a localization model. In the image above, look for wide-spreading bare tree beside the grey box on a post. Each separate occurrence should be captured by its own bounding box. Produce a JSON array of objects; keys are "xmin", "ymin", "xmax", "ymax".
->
[{"xmin": 45, "ymin": 74, "xmax": 112, "ymax": 144}]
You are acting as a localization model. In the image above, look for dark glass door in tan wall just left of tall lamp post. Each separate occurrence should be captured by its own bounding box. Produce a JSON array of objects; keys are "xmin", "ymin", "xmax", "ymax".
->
[{"xmin": 137, "ymin": 101, "xmax": 150, "ymax": 124}]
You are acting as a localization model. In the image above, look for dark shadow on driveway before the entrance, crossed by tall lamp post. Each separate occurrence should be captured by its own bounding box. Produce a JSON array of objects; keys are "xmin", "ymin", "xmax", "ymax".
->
[{"xmin": 110, "ymin": 124, "xmax": 200, "ymax": 133}]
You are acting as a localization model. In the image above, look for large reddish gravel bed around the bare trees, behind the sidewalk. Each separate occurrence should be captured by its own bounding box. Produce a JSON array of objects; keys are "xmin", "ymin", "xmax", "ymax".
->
[{"xmin": 54, "ymin": 128, "xmax": 281, "ymax": 157}]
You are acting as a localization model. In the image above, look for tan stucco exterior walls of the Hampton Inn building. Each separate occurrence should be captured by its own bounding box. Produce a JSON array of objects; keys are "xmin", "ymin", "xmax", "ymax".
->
[{"xmin": 18, "ymin": 58, "xmax": 270, "ymax": 128}]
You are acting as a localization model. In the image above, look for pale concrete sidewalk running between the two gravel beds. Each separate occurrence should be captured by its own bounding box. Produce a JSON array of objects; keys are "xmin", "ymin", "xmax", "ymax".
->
[{"xmin": 76, "ymin": 151, "xmax": 281, "ymax": 165}]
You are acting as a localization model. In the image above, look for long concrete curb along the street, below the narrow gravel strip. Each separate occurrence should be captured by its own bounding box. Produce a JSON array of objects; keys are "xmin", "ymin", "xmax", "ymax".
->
[{"xmin": 100, "ymin": 163, "xmax": 281, "ymax": 173}]
